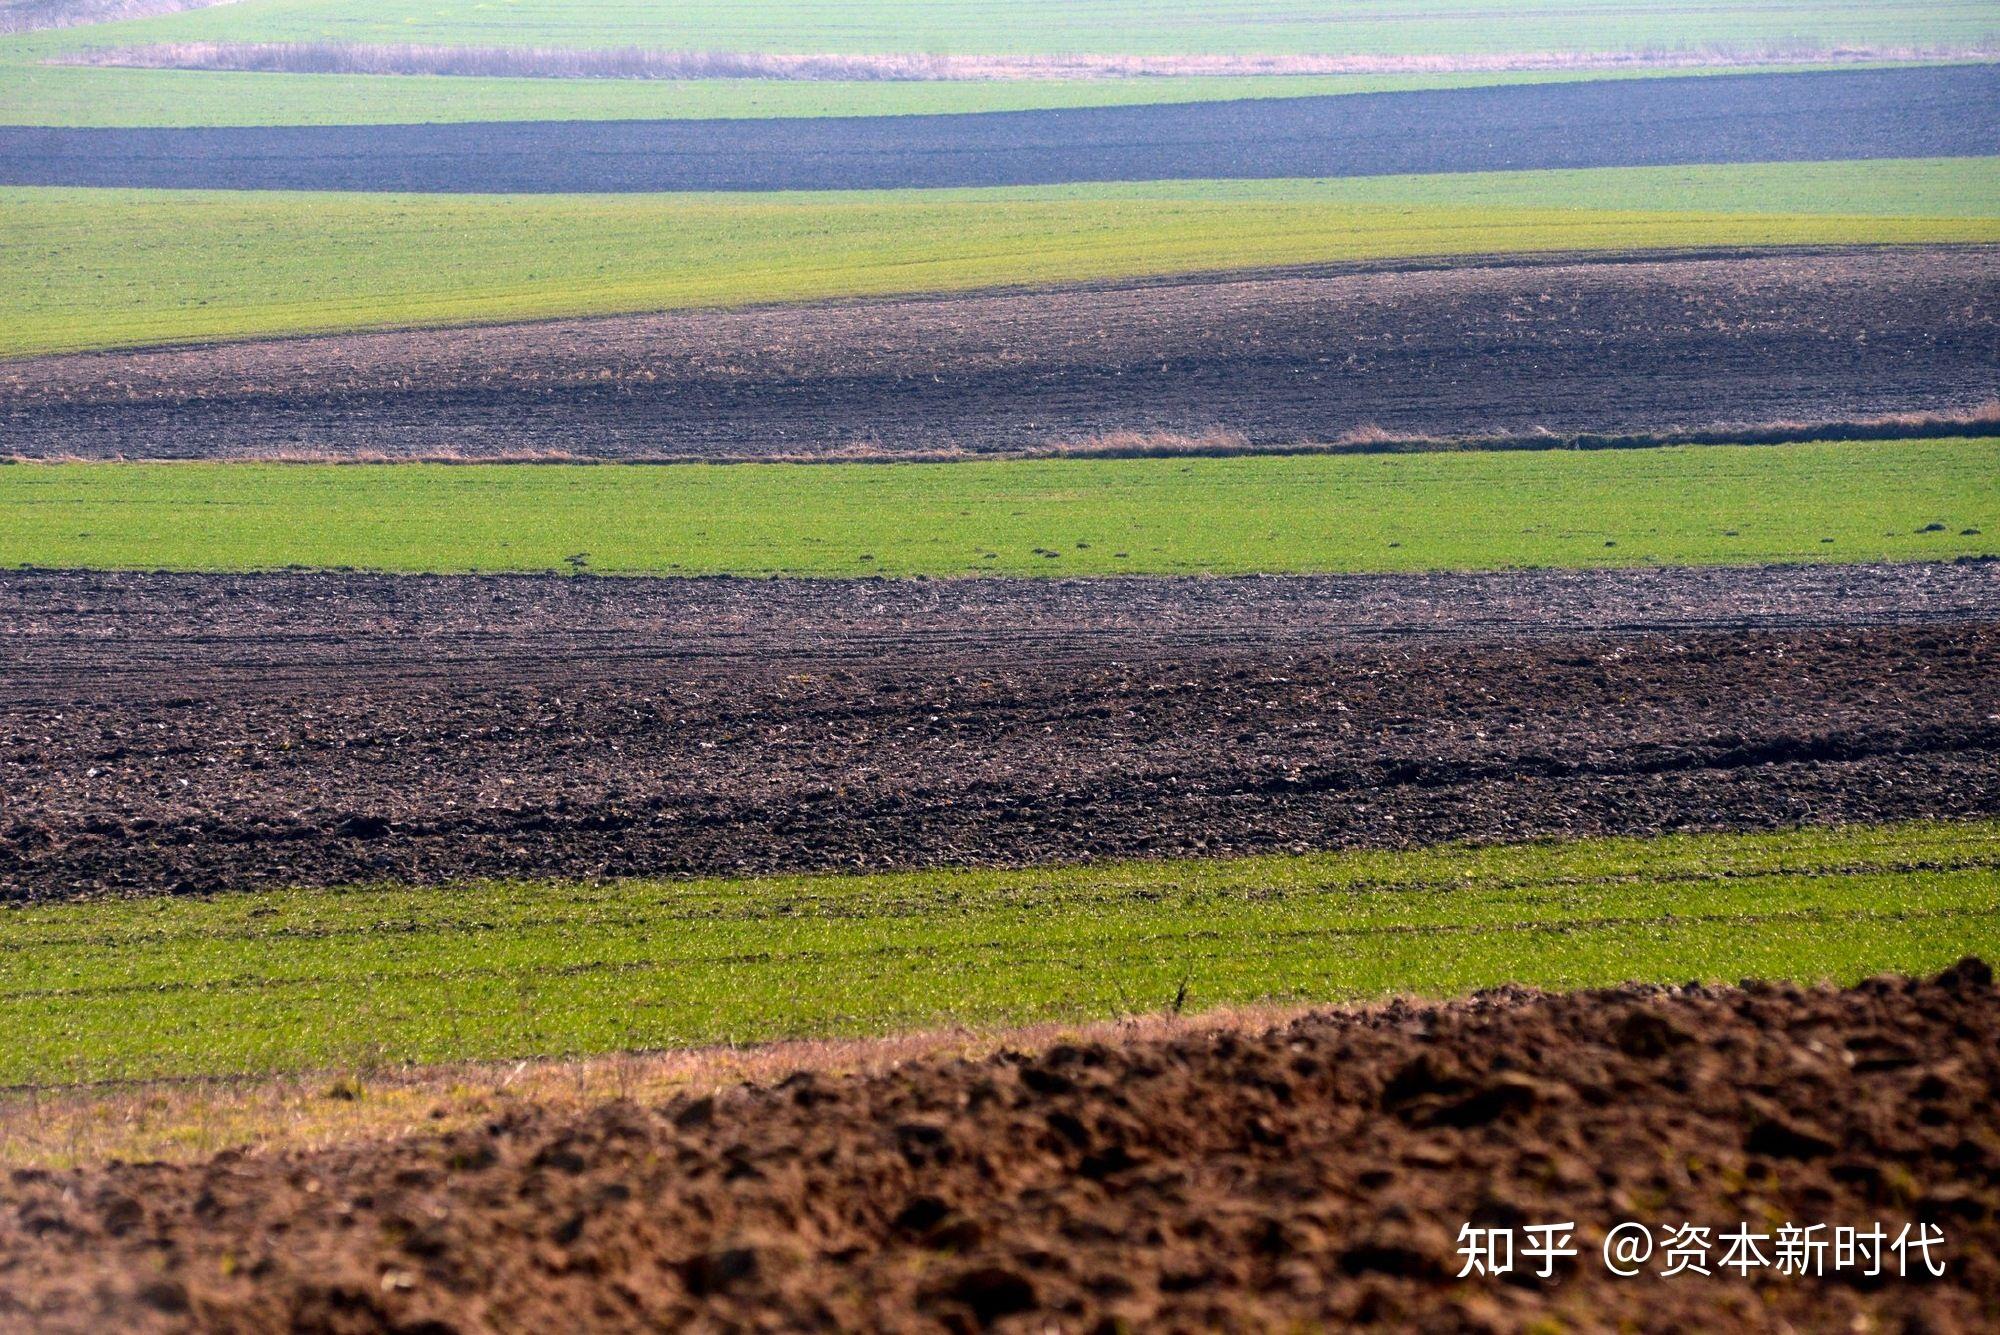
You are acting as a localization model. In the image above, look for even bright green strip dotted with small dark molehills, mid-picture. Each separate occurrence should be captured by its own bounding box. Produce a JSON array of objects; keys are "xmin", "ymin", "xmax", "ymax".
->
[{"xmin": 0, "ymin": 440, "xmax": 2000, "ymax": 576}]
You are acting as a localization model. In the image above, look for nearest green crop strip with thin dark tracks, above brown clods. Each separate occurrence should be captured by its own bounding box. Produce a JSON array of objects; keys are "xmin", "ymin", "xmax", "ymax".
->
[{"xmin": 0, "ymin": 821, "xmax": 2000, "ymax": 1083}]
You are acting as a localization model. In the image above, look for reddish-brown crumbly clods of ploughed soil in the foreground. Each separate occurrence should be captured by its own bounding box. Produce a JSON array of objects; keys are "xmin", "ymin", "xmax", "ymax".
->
[{"xmin": 0, "ymin": 961, "xmax": 2000, "ymax": 1333}]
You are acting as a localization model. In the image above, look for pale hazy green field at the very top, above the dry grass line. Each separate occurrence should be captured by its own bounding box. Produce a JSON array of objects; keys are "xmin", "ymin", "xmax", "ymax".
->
[{"xmin": 14, "ymin": 0, "xmax": 2000, "ymax": 54}]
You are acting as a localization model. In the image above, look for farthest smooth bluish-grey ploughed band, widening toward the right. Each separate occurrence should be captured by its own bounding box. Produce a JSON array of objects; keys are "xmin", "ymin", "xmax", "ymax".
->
[{"xmin": 0, "ymin": 66, "xmax": 2000, "ymax": 194}]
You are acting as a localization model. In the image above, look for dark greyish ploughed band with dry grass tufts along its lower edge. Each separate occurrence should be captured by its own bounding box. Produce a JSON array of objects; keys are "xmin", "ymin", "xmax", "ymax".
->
[{"xmin": 0, "ymin": 246, "xmax": 2000, "ymax": 458}]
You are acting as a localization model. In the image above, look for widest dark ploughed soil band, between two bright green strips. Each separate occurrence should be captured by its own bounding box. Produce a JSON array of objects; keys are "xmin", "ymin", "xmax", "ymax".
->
[{"xmin": 0, "ymin": 562, "xmax": 2000, "ymax": 899}]
